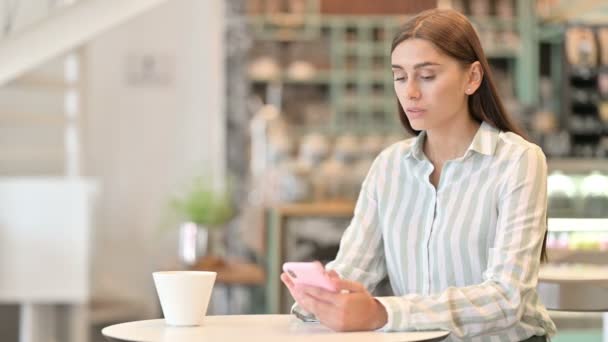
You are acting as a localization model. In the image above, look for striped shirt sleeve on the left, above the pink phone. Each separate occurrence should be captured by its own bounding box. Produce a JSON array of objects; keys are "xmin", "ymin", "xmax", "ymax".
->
[{"xmin": 291, "ymin": 154, "xmax": 386, "ymax": 316}]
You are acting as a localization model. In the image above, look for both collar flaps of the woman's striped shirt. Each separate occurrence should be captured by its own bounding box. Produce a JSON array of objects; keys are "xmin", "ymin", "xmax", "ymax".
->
[{"xmin": 405, "ymin": 121, "xmax": 500, "ymax": 161}]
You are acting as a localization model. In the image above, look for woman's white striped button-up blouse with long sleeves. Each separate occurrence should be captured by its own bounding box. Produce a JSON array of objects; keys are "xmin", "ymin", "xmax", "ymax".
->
[{"xmin": 298, "ymin": 123, "xmax": 555, "ymax": 341}]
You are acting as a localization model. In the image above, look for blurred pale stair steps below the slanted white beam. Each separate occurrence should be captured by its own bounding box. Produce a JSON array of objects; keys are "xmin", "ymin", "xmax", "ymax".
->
[{"xmin": 0, "ymin": 50, "xmax": 84, "ymax": 177}]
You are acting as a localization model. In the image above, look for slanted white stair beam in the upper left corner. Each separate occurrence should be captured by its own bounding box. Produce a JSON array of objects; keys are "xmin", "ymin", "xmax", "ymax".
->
[{"xmin": 0, "ymin": 0, "xmax": 167, "ymax": 84}]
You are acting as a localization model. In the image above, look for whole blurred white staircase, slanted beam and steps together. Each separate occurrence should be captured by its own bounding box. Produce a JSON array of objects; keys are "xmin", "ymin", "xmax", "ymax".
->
[{"xmin": 0, "ymin": 0, "xmax": 166, "ymax": 177}]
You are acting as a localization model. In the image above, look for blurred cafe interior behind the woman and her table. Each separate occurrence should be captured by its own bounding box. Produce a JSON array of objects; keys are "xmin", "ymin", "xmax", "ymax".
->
[{"xmin": 0, "ymin": 0, "xmax": 608, "ymax": 342}]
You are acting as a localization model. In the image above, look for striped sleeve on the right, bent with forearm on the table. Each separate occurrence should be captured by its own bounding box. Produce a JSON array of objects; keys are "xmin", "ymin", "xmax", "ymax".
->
[{"xmin": 376, "ymin": 146, "xmax": 547, "ymax": 338}]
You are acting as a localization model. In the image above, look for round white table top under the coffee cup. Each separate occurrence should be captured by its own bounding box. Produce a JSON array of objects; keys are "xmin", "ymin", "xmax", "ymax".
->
[{"xmin": 101, "ymin": 315, "xmax": 449, "ymax": 342}]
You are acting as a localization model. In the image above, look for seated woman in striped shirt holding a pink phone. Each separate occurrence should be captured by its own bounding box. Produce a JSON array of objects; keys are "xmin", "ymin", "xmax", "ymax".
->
[{"xmin": 281, "ymin": 10, "xmax": 555, "ymax": 341}]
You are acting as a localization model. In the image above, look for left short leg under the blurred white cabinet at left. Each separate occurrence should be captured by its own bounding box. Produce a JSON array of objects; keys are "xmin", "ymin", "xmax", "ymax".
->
[{"xmin": 19, "ymin": 303, "xmax": 57, "ymax": 342}]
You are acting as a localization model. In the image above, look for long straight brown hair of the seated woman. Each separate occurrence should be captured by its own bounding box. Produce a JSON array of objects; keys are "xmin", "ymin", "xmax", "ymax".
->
[{"xmin": 391, "ymin": 9, "xmax": 547, "ymax": 261}]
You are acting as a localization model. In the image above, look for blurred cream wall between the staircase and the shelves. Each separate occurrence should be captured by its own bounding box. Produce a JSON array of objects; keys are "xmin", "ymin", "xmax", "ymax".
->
[{"xmin": 84, "ymin": 0, "xmax": 225, "ymax": 316}]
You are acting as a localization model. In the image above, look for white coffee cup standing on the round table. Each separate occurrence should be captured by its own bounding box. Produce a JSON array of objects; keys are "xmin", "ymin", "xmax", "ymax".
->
[{"xmin": 152, "ymin": 271, "xmax": 217, "ymax": 326}]
